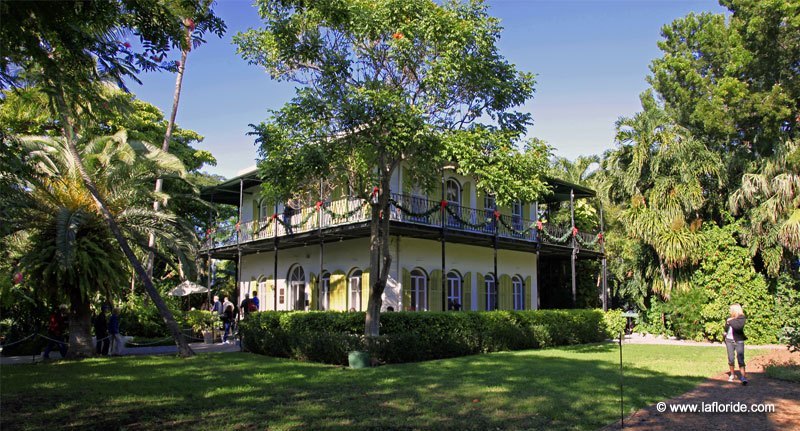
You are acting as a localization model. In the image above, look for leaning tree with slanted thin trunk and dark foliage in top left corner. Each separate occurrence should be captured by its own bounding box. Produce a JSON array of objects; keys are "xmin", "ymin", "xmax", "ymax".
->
[{"xmin": 0, "ymin": 0, "xmax": 221, "ymax": 356}]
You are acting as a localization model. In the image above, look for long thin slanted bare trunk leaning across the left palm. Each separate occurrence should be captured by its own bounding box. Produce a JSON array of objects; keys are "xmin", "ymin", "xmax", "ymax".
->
[{"xmin": 54, "ymin": 83, "xmax": 194, "ymax": 357}]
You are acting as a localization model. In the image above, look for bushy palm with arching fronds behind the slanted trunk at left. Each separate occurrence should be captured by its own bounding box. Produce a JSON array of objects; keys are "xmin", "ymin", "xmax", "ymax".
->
[{"xmin": 2, "ymin": 131, "xmax": 194, "ymax": 357}]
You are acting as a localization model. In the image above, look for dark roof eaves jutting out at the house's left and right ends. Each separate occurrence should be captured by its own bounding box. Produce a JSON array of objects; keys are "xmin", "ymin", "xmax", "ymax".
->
[{"xmin": 200, "ymin": 169, "xmax": 597, "ymax": 206}]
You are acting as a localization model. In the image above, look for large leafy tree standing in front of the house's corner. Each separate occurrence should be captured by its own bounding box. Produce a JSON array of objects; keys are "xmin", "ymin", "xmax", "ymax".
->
[{"xmin": 234, "ymin": 0, "xmax": 547, "ymax": 335}]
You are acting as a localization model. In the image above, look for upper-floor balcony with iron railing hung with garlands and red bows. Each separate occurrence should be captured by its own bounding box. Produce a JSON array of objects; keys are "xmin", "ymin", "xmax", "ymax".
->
[{"xmin": 204, "ymin": 194, "xmax": 602, "ymax": 255}]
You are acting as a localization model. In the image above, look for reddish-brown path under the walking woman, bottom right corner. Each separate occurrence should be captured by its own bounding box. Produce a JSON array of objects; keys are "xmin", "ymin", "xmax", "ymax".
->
[{"xmin": 603, "ymin": 349, "xmax": 800, "ymax": 431}]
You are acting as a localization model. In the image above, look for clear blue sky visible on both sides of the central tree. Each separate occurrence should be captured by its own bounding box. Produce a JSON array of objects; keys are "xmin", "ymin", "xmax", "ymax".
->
[{"xmin": 130, "ymin": 0, "xmax": 725, "ymax": 178}]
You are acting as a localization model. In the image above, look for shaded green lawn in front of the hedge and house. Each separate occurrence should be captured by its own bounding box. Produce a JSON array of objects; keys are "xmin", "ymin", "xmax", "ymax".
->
[{"xmin": 0, "ymin": 344, "xmax": 768, "ymax": 431}]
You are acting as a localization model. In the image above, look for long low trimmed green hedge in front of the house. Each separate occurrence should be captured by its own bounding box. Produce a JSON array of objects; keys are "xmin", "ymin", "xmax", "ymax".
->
[{"xmin": 240, "ymin": 310, "xmax": 608, "ymax": 365}]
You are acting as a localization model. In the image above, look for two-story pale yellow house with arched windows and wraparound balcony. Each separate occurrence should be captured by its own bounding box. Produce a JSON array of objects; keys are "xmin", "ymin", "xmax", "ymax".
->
[{"xmin": 202, "ymin": 167, "xmax": 605, "ymax": 311}]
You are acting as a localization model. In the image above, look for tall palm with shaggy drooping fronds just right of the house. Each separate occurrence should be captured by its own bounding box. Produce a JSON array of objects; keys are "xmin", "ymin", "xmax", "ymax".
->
[{"xmin": 601, "ymin": 92, "xmax": 722, "ymax": 298}]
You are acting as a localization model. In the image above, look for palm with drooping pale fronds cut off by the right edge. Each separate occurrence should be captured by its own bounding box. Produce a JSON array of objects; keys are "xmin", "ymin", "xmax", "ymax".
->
[{"xmin": 729, "ymin": 141, "xmax": 800, "ymax": 276}]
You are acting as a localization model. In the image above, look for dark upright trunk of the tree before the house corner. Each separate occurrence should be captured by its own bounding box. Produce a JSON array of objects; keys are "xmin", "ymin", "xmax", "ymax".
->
[{"xmin": 364, "ymin": 168, "xmax": 392, "ymax": 337}]
